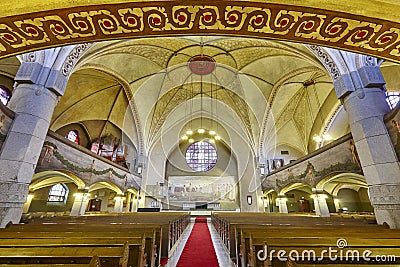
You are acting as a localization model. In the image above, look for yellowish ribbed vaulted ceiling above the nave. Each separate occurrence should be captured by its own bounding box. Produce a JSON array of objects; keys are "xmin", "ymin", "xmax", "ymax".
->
[{"xmin": 47, "ymin": 36, "xmax": 339, "ymax": 158}]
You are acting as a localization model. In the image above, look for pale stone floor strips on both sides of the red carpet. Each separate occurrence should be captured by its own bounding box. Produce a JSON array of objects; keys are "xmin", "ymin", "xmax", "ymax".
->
[{"xmin": 166, "ymin": 218, "xmax": 235, "ymax": 267}]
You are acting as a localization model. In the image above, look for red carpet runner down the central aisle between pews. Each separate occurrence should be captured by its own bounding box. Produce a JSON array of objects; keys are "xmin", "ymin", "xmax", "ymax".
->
[{"xmin": 176, "ymin": 218, "xmax": 219, "ymax": 267}]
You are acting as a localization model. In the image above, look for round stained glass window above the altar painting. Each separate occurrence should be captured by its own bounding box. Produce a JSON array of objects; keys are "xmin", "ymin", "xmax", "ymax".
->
[{"xmin": 186, "ymin": 141, "xmax": 217, "ymax": 172}]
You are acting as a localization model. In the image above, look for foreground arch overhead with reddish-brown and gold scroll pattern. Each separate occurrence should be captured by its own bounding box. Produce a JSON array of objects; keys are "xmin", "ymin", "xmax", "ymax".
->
[{"xmin": 0, "ymin": 0, "xmax": 400, "ymax": 61}]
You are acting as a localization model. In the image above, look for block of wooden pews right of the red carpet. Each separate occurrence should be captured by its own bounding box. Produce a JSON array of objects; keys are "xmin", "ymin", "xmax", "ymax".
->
[{"xmin": 212, "ymin": 213, "xmax": 400, "ymax": 266}]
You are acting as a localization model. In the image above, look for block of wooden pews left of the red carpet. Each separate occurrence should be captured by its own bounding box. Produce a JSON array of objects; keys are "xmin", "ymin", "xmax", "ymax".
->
[{"xmin": 0, "ymin": 213, "xmax": 190, "ymax": 267}]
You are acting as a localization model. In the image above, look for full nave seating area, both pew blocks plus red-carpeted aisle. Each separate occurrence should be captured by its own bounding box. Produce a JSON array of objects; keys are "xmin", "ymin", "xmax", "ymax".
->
[{"xmin": 0, "ymin": 212, "xmax": 400, "ymax": 267}]
